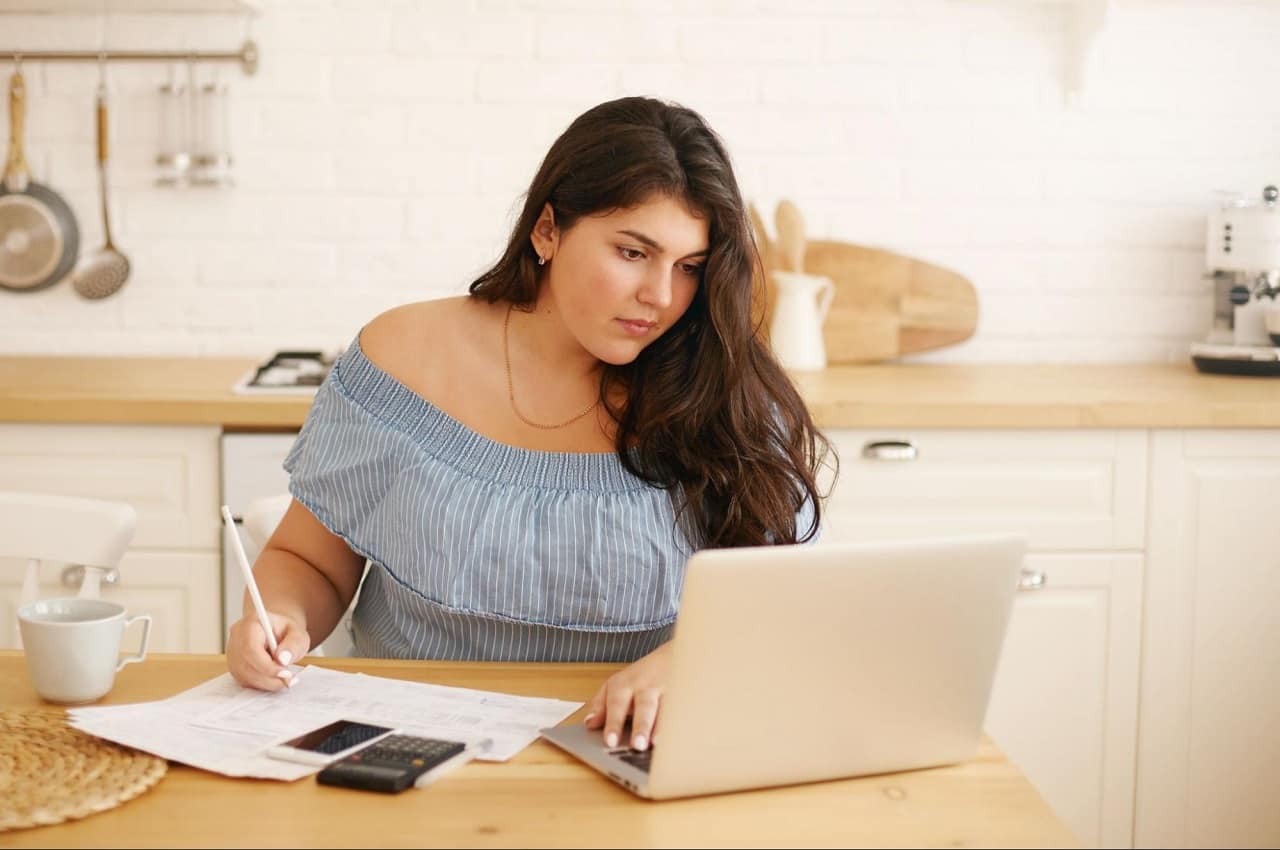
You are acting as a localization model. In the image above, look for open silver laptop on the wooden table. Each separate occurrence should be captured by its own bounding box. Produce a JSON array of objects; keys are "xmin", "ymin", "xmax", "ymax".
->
[{"xmin": 543, "ymin": 535, "xmax": 1025, "ymax": 799}]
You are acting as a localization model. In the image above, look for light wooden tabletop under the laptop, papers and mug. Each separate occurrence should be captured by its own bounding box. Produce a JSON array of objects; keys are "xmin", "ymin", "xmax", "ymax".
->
[{"xmin": 0, "ymin": 650, "xmax": 1080, "ymax": 847}]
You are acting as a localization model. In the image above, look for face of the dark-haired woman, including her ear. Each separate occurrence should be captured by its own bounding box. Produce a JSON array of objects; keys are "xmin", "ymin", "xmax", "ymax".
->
[{"xmin": 534, "ymin": 196, "xmax": 709, "ymax": 365}]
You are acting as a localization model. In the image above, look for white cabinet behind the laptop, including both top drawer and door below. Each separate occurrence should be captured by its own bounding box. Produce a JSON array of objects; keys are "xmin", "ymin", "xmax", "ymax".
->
[{"xmin": 822, "ymin": 429, "xmax": 1148, "ymax": 846}]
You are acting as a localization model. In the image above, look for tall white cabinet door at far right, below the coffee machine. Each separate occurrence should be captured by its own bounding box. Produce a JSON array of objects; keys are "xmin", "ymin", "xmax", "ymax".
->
[{"xmin": 1135, "ymin": 429, "xmax": 1280, "ymax": 847}]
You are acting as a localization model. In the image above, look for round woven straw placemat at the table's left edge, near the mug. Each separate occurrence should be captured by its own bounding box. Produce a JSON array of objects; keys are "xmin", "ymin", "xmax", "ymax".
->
[{"xmin": 0, "ymin": 709, "xmax": 169, "ymax": 832}]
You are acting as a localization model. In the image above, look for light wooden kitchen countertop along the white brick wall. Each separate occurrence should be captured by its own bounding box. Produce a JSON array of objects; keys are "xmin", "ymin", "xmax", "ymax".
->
[{"xmin": 0, "ymin": 356, "xmax": 1280, "ymax": 430}]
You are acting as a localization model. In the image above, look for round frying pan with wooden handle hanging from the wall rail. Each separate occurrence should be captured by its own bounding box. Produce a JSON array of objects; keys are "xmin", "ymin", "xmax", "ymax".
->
[{"xmin": 0, "ymin": 70, "xmax": 79, "ymax": 292}]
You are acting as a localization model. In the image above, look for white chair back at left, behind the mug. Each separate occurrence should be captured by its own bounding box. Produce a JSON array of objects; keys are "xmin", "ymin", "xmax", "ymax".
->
[{"xmin": 0, "ymin": 490, "xmax": 138, "ymax": 645}]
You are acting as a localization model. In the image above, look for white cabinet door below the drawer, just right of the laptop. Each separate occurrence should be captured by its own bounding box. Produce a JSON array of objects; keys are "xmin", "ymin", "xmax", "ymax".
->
[{"xmin": 987, "ymin": 553, "xmax": 1143, "ymax": 847}]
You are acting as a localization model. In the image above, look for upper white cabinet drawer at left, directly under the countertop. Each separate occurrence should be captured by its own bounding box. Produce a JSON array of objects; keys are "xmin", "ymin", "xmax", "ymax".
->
[{"xmin": 0, "ymin": 424, "xmax": 219, "ymax": 549}]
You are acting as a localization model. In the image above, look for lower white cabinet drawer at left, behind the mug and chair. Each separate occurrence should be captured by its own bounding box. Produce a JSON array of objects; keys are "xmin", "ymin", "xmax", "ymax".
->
[{"xmin": 0, "ymin": 550, "xmax": 223, "ymax": 653}]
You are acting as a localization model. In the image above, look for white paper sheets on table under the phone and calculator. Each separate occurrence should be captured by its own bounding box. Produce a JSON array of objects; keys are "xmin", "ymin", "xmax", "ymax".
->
[{"xmin": 67, "ymin": 666, "xmax": 582, "ymax": 780}]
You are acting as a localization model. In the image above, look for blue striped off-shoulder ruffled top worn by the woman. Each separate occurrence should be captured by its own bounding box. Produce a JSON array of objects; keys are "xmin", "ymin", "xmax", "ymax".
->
[{"xmin": 284, "ymin": 335, "xmax": 812, "ymax": 662}]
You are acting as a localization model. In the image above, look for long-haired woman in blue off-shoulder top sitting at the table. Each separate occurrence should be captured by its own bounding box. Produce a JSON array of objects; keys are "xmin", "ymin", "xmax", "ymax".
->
[{"xmin": 227, "ymin": 97, "xmax": 826, "ymax": 749}]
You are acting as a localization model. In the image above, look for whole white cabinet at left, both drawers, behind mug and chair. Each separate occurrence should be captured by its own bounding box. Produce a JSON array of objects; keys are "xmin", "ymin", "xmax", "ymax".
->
[{"xmin": 0, "ymin": 424, "xmax": 221, "ymax": 653}]
